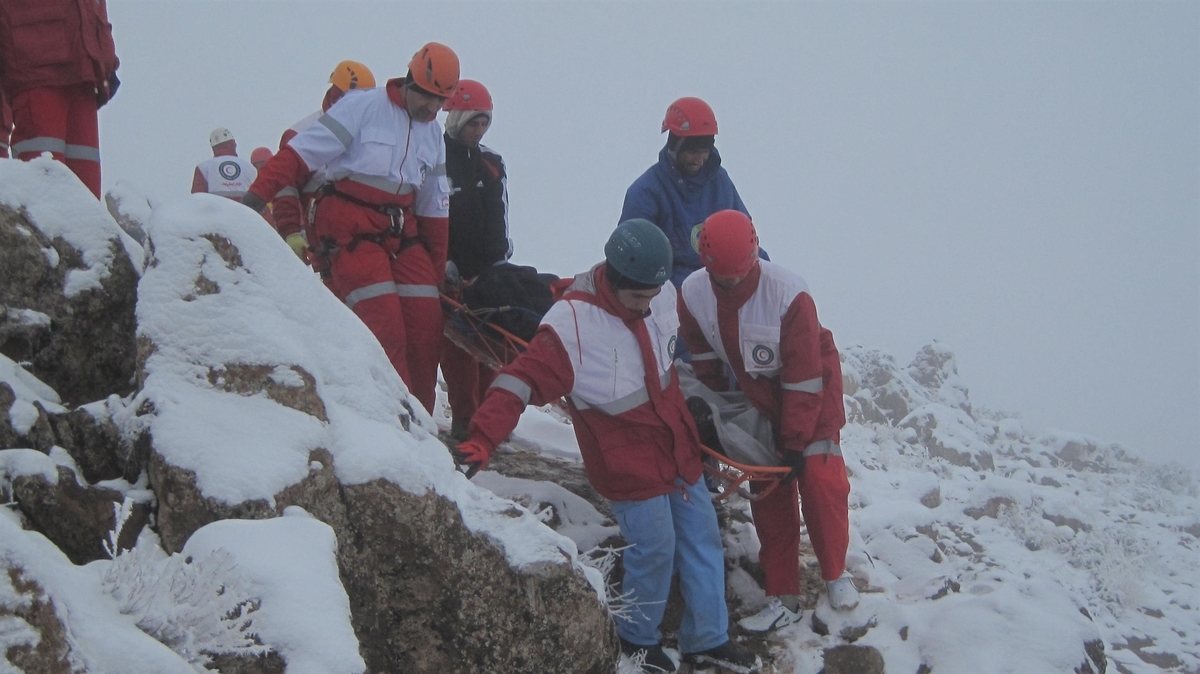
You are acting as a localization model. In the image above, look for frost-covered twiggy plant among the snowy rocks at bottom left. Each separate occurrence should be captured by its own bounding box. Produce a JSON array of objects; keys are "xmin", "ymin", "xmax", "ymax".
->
[{"xmin": 103, "ymin": 499, "xmax": 270, "ymax": 672}]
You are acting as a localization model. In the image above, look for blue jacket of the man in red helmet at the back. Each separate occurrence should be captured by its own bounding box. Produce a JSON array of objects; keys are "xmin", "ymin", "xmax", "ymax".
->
[{"xmin": 618, "ymin": 145, "xmax": 750, "ymax": 288}]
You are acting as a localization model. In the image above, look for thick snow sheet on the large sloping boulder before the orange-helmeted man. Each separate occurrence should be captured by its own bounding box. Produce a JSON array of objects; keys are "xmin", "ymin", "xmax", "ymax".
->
[{"xmin": 132, "ymin": 194, "xmax": 600, "ymax": 568}]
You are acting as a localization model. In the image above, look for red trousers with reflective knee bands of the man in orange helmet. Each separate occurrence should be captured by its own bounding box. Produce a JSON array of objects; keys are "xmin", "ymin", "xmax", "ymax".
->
[{"xmin": 314, "ymin": 198, "xmax": 443, "ymax": 413}]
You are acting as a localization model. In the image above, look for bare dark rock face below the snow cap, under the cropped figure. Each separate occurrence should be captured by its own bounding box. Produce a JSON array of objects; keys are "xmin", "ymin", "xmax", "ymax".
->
[{"xmin": 0, "ymin": 205, "xmax": 138, "ymax": 404}]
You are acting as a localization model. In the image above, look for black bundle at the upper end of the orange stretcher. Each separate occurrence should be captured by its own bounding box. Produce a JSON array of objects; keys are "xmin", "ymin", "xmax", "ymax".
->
[{"xmin": 462, "ymin": 263, "xmax": 558, "ymax": 342}]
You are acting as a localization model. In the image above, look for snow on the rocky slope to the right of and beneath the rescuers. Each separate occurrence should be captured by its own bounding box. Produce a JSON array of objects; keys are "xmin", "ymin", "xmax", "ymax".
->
[{"xmin": 451, "ymin": 344, "xmax": 1200, "ymax": 674}]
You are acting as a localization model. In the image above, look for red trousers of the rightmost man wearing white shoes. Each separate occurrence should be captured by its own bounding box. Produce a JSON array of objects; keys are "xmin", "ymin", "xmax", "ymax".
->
[{"xmin": 750, "ymin": 455, "xmax": 850, "ymax": 596}]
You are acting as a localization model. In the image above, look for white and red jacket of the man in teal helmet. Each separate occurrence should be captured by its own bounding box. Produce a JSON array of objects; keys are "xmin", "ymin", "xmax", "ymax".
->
[{"xmin": 470, "ymin": 265, "xmax": 703, "ymax": 501}]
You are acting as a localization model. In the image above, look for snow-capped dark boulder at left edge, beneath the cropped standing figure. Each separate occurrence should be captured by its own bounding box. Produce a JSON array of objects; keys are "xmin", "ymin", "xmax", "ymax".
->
[{"xmin": 0, "ymin": 157, "xmax": 142, "ymax": 404}]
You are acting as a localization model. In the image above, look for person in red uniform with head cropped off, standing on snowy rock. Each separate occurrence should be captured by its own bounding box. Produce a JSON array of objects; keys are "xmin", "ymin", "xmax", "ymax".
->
[{"xmin": 0, "ymin": 0, "xmax": 120, "ymax": 199}]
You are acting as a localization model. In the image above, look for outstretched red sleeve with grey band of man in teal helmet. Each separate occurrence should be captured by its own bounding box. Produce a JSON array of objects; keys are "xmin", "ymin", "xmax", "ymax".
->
[{"xmin": 469, "ymin": 325, "xmax": 575, "ymax": 450}]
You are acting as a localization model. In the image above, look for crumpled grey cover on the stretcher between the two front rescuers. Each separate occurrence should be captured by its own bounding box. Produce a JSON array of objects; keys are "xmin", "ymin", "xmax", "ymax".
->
[{"xmin": 676, "ymin": 360, "xmax": 782, "ymax": 467}]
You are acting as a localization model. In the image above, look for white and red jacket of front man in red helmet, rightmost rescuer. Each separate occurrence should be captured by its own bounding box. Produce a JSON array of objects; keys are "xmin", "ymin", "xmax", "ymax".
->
[{"xmin": 679, "ymin": 260, "xmax": 846, "ymax": 456}]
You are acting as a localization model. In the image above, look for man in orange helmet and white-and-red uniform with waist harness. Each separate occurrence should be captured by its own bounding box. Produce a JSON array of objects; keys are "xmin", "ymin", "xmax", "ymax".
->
[{"xmin": 242, "ymin": 42, "xmax": 458, "ymax": 411}]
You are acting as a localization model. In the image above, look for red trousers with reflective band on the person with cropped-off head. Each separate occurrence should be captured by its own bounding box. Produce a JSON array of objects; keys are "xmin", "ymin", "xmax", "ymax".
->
[{"xmin": 12, "ymin": 83, "xmax": 100, "ymax": 199}]
